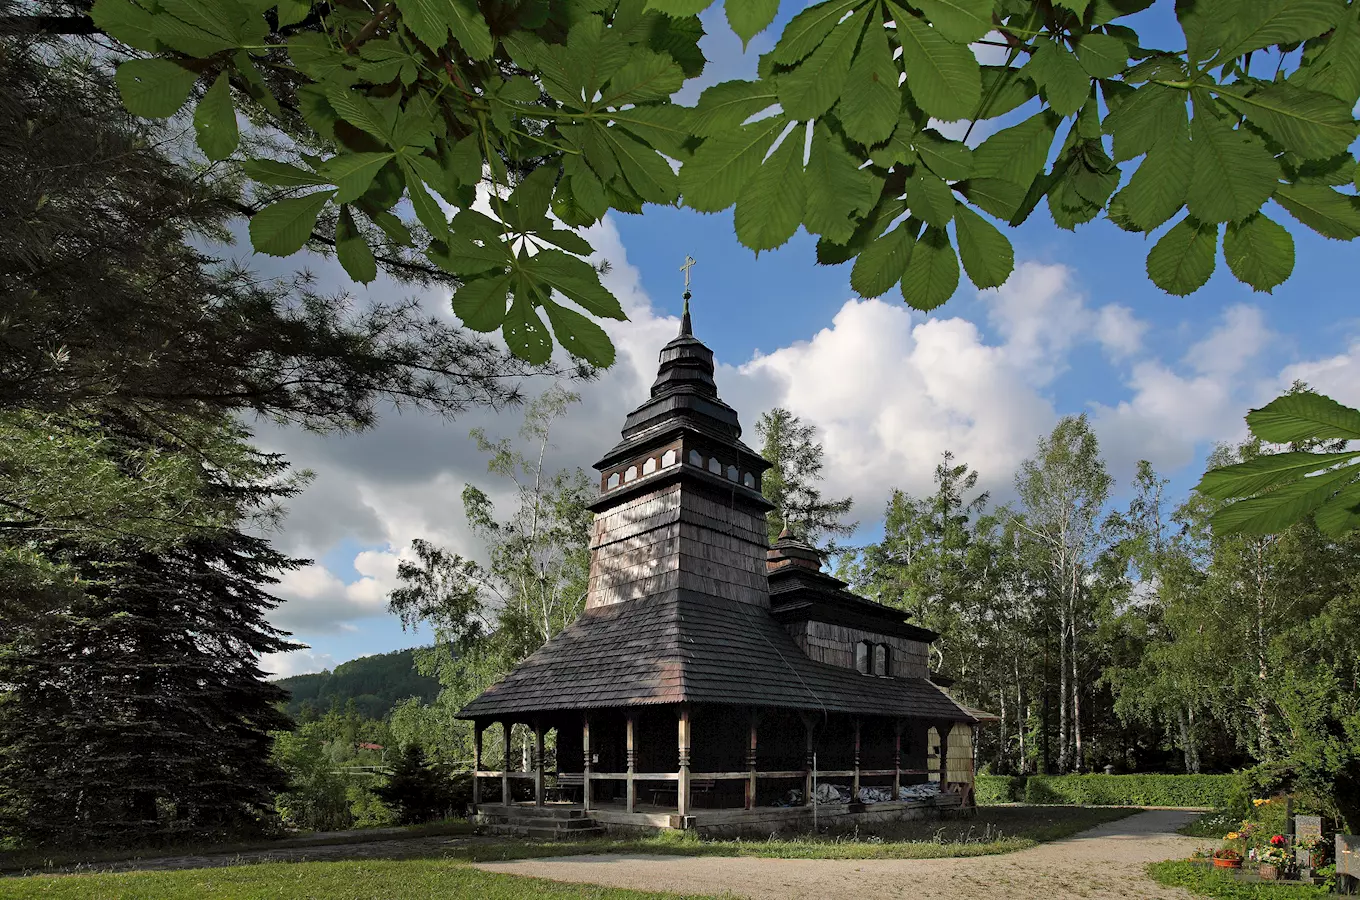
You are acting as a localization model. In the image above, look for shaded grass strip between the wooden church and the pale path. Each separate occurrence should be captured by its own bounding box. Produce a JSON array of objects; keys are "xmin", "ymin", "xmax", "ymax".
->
[{"xmin": 454, "ymin": 806, "xmax": 1138, "ymax": 862}]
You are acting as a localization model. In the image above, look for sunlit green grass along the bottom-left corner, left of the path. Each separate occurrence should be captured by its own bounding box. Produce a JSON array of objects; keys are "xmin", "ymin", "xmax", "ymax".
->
[{"xmin": 0, "ymin": 859, "xmax": 698, "ymax": 900}]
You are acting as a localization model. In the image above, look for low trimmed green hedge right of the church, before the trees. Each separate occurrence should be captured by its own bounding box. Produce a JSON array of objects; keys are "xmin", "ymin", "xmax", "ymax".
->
[{"xmin": 975, "ymin": 775, "xmax": 1240, "ymax": 809}]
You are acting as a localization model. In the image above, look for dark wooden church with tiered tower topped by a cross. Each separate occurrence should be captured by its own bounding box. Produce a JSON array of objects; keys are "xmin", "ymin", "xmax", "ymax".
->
[{"xmin": 458, "ymin": 292, "xmax": 978, "ymax": 833}]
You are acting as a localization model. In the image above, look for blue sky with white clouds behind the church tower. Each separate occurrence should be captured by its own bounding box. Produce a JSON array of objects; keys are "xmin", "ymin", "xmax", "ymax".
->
[{"xmin": 250, "ymin": 3, "xmax": 1360, "ymax": 673}]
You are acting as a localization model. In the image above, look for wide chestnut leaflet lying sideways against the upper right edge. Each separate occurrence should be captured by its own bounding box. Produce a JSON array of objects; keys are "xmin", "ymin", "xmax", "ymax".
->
[{"xmin": 1216, "ymin": 82, "xmax": 1357, "ymax": 159}]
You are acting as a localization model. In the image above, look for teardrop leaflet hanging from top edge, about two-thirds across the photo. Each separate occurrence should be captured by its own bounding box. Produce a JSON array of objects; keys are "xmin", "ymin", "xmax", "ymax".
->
[{"xmin": 891, "ymin": 4, "xmax": 982, "ymax": 122}]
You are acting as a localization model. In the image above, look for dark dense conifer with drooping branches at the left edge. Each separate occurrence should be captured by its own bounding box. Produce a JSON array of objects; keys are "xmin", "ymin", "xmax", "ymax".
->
[{"xmin": 0, "ymin": 426, "xmax": 301, "ymax": 847}]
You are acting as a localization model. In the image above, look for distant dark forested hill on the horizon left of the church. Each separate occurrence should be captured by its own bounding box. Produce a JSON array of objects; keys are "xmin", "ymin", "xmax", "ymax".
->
[{"xmin": 275, "ymin": 650, "xmax": 439, "ymax": 719}]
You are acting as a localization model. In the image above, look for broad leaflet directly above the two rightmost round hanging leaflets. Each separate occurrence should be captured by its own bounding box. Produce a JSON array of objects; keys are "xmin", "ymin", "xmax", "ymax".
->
[{"xmin": 1186, "ymin": 106, "xmax": 1280, "ymax": 222}]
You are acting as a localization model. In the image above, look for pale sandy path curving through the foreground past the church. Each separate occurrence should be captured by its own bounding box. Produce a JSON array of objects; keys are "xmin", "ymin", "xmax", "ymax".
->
[{"xmin": 480, "ymin": 810, "xmax": 1202, "ymax": 900}]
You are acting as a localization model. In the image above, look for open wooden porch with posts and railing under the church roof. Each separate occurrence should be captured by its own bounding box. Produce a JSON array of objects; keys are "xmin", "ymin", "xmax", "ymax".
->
[{"xmin": 473, "ymin": 703, "xmax": 972, "ymax": 829}]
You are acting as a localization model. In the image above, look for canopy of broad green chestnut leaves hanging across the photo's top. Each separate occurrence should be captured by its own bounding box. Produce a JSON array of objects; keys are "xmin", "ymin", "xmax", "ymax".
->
[{"xmin": 61, "ymin": 0, "xmax": 1360, "ymax": 364}]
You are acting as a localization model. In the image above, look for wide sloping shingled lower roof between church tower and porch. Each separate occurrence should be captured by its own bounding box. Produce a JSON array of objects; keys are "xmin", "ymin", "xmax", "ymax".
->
[{"xmin": 458, "ymin": 590, "xmax": 974, "ymax": 722}]
